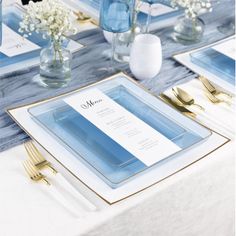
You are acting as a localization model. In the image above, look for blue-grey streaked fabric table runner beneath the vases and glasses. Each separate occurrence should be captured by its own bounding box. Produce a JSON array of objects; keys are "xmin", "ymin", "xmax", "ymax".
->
[{"xmin": 0, "ymin": 0, "xmax": 235, "ymax": 151}]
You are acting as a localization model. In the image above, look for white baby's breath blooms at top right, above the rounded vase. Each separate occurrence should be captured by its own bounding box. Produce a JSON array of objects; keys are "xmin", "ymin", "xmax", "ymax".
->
[{"xmin": 171, "ymin": 0, "xmax": 212, "ymax": 19}]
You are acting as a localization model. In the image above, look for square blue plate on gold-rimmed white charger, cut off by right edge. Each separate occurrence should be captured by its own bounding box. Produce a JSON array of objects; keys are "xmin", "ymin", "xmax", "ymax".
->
[{"xmin": 173, "ymin": 35, "xmax": 235, "ymax": 93}]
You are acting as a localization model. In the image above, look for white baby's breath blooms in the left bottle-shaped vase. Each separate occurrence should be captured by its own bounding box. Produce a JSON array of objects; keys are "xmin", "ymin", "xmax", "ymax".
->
[{"xmin": 19, "ymin": 0, "xmax": 76, "ymax": 43}]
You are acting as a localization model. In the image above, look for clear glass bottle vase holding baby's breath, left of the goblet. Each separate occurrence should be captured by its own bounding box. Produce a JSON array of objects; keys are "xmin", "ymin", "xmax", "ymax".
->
[{"xmin": 39, "ymin": 40, "xmax": 72, "ymax": 88}]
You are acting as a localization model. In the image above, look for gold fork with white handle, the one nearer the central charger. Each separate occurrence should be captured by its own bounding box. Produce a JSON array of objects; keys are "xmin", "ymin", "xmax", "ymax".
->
[{"xmin": 24, "ymin": 141, "xmax": 97, "ymax": 211}]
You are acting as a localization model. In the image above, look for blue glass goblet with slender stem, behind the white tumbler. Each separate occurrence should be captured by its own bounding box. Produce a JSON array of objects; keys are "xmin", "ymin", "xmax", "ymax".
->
[{"xmin": 100, "ymin": 0, "xmax": 134, "ymax": 68}]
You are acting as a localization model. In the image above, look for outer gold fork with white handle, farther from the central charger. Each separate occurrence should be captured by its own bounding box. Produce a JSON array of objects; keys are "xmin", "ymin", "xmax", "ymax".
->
[{"xmin": 23, "ymin": 160, "xmax": 77, "ymax": 216}]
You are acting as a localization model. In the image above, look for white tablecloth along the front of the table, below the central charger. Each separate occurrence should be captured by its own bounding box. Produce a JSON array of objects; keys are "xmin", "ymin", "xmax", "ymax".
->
[{"xmin": 0, "ymin": 139, "xmax": 235, "ymax": 236}]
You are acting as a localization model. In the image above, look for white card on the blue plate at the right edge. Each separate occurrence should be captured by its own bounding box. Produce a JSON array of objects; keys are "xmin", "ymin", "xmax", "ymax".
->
[{"xmin": 212, "ymin": 38, "xmax": 236, "ymax": 60}]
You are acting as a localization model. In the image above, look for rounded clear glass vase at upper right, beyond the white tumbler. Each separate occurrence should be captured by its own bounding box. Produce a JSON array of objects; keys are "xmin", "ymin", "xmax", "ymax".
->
[{"xmin": 173, "ymin": 16, "xmax": 205, "ymax": 45}]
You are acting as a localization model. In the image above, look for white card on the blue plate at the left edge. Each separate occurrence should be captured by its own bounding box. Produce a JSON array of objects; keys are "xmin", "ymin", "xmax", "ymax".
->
[{"xmin": 0, "ymin": 24, "xmax": 40, "ymax": 57}]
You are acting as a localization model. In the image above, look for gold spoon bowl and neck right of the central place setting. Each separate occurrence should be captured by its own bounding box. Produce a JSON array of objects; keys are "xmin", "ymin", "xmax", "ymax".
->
[{"xmin": 172, "ymin": 87, "xmax": 205, "ymax": 111}]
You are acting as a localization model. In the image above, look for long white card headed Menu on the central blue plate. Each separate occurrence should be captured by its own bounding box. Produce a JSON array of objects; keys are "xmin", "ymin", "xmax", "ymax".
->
[{"xmin": 64, "ymin": 89, "xmax": 181, "ymax": 166}]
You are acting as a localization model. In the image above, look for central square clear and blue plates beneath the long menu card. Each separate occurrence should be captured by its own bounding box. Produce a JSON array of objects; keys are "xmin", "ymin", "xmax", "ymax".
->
[{"xmin": 28, "ymin": 75, "xmax": 211, "ymax": 188}]
